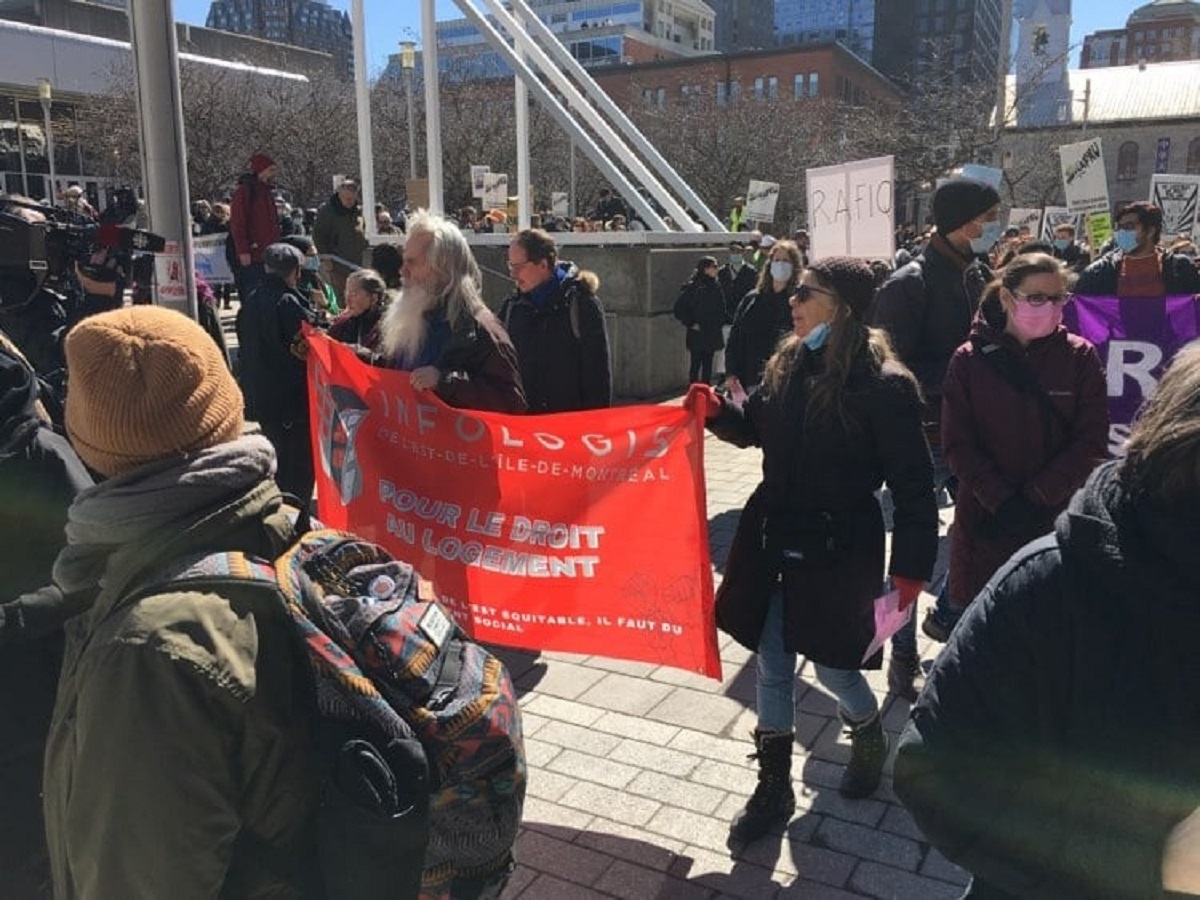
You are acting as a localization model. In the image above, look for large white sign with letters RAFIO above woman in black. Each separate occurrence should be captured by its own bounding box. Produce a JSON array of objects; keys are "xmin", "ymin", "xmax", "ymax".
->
[{"xmin": 805, "ymin": 156, "xmax": 895, "ymax": 259}]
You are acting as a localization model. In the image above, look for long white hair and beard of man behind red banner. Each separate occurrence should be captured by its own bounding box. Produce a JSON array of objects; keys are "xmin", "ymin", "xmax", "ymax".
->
[{"xmin": 379, "ymin": 210, "xmax": 487, "ymax": 360}]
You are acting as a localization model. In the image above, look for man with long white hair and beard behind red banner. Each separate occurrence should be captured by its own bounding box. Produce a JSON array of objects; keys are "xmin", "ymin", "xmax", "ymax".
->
[{"xmin": 380, "ymin": 212, "xmax": 526, "ymax": 413}]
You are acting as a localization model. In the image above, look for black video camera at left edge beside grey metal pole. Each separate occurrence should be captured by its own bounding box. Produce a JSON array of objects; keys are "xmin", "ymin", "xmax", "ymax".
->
[{"xmin": 0, "ymin": 191, "xmax": 167, "ymax": 307}]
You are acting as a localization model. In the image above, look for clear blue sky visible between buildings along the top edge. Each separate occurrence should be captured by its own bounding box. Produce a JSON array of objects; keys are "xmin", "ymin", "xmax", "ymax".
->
[{"xmin": 174, "ymin": 0, "xmax": 1145, "ymax": 74}]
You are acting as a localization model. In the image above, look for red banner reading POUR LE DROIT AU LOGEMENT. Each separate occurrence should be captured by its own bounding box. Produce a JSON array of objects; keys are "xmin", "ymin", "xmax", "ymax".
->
[{"xmin": 308, "ymin": 334, "xmax": 721, "ymax": 678}]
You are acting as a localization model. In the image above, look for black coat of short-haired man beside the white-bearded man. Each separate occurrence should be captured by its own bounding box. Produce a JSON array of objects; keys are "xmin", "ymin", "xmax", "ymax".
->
[{"xmin": 500, "ymin": 262, "xmax": 612, "ymax": 413}]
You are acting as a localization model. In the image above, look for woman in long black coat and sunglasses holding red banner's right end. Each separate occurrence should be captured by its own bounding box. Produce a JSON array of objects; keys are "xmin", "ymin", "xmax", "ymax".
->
[{"xmin": 690, "ymin": 257, "xmax": 937, "ymax": 842}]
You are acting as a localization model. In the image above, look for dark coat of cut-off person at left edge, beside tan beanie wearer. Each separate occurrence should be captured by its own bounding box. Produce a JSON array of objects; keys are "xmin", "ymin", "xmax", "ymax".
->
[{"xmin": 0, "ymin": 350, "xmax": 91, "ymax": 898}]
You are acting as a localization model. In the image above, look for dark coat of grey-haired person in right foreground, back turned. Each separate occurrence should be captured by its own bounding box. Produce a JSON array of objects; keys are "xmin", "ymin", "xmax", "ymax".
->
[{"xmin": 895, "ymin": 462, "xmax": 1200, "ymax": 900}]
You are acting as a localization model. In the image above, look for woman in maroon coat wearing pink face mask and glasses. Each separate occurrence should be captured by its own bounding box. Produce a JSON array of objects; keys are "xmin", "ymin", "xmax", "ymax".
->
[{"xmin": 942, "ymin": 253, "xmax": 1109, "ymax": 626}]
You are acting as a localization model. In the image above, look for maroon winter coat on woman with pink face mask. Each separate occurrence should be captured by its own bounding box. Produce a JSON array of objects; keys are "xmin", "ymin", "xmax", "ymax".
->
[{"xmin": 942, "ymin": 300, "xmax": 1109, "ymax": 608}]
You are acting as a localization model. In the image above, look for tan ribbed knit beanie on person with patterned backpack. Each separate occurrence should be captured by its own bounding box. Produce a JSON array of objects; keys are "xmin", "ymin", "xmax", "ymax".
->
[{"xmin": 66, "ymin": 306, "xmax": 242, "ymax": 476}]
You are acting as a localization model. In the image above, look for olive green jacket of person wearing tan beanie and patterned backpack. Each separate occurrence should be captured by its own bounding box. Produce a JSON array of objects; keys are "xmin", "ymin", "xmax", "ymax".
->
[{"xmin": 44, "ymin": 480, "xmax": 318, "ymax": 900}]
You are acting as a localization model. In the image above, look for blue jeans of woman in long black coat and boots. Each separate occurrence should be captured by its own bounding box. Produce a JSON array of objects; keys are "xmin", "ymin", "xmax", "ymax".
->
[{"xmin": 756, "ymin": 589, "xmax": 880, "ymax": 731}]
